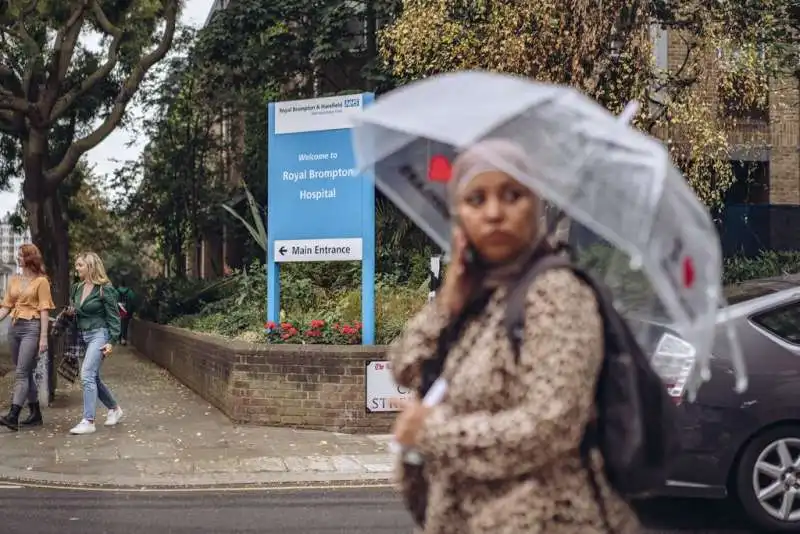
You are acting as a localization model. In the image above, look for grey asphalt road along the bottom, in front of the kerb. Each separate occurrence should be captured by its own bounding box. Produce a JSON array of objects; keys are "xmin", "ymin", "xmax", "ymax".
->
[{"xmin": 0, "ymin": 485, "xmax": 754, "ymax": 534}]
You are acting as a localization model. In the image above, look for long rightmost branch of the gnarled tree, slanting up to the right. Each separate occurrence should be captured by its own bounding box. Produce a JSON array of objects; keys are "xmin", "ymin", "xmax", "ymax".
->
[{"xmin": 45, "ymin": 0, "xmax": 178, "ymax": 191}]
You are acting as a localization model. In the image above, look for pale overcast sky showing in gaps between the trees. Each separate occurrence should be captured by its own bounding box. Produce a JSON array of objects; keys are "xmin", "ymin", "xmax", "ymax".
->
[{"xmin": 0, "ymin": 0, "xmax": 214, "ymax": 217}]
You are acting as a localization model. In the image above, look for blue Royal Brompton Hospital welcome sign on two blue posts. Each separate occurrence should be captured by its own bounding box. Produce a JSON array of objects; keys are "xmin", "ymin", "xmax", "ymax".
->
[{"xmin": 267, "ymin": 93, "xmax": 375, "ymax": 345}]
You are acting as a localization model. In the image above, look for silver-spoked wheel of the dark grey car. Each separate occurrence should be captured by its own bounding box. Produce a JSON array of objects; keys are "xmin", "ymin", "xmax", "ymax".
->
[{"xmin": 736, "ymin": 425, "xmax": 800, "ymax": 532}]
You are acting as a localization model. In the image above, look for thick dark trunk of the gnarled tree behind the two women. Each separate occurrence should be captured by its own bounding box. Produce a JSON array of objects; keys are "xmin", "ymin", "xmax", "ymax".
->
[{"xmin": 25, "ymin": 192, "xmax": 70, "ymax": 306}]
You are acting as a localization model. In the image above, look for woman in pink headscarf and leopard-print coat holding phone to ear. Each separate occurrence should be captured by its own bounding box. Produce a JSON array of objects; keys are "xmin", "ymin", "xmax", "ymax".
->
[{"xmin": 390, "ymin": 140, "xmax": 639, "ymax": 534}]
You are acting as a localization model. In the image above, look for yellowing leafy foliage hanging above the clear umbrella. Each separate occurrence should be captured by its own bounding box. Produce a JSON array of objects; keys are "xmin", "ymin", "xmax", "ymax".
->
[{"xmin": 380, "ymin": 0, "xmax": 797, "ymax": 205}]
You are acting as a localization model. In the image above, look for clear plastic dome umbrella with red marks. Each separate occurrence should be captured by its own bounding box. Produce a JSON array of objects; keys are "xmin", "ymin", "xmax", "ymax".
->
[{"xmin": 353, "ymin": 71, "xmax": 747, "ymax": 398}]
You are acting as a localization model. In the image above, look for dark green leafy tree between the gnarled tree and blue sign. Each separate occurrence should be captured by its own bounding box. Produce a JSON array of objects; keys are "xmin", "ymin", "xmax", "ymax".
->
[{"xmin": 115, "ymin": 36, "xmax": 226, "ymax": 276}]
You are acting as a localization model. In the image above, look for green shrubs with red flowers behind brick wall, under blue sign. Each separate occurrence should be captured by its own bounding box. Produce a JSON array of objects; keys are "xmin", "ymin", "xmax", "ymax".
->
[{"xmin": 160, "ymin": 262, "xmax": 428, "ymax": 344}]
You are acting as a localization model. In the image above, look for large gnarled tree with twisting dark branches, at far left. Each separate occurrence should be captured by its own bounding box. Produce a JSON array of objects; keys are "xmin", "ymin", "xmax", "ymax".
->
[{"xmin": 0, "ymin": 0, "xmax": 179, "ymax": 300}]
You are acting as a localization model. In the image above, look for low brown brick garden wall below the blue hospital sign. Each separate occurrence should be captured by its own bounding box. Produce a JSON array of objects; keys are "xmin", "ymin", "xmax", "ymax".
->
[{"xmin": 130, "ymin": 320, "xmax": 395, "ymax": 433}]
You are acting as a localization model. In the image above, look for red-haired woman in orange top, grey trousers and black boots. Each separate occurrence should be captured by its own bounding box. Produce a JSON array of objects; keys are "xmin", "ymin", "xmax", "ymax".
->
[{"xmin": 0, "ymin": 244, "xmax": 55, "ymax": 430}]
